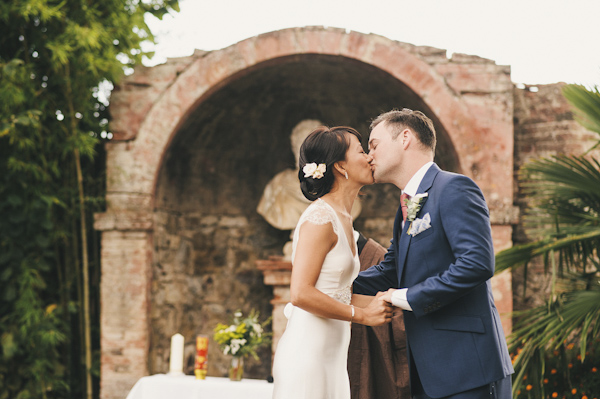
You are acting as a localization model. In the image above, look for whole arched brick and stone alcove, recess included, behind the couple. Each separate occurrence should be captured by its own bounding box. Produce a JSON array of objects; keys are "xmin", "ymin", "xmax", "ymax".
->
[{"xmin": 95, "ymin": 27, "xmax": 516, "ymax": 399}]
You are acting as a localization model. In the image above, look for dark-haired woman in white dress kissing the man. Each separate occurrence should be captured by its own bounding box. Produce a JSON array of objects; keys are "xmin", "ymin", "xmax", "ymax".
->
[{"xmin": 273, "ymin": 127, "xmax": 392, "ymax": 399}]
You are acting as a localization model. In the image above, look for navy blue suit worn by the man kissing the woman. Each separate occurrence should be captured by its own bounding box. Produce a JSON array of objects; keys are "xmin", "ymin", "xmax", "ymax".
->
[{"xmin": 354, "ymin": 164, "xmax": 514, "ymax": 398}]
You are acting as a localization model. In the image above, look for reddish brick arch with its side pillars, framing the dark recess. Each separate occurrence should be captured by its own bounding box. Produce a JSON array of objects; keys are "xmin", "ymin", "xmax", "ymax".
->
[{"xmin": 95, "ymin": 27, "xmax": 513, "ymax": 398}]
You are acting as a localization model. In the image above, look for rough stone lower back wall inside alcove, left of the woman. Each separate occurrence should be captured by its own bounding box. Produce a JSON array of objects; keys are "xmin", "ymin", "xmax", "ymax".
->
[{"xmin": 149, "ymin": 210, "xmax": 276, "ymax": 379}]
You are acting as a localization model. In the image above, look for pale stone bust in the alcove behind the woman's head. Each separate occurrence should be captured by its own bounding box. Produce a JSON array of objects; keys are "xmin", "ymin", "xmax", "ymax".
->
[{"xmin": 256, "ymin": 119, "xmax": 361, "ymax": 260}]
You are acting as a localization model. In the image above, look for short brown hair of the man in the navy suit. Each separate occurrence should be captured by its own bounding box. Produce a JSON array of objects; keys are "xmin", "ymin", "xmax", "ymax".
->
[{"xmin": 371, "ymin": 108, "xmax": 436, "ymax": 154}]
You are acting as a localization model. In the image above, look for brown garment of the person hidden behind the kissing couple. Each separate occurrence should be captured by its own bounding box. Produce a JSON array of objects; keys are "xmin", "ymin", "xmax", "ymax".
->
[{"xmin": 348, "ymin": 239, "xmax": 410, "ymax": 399}]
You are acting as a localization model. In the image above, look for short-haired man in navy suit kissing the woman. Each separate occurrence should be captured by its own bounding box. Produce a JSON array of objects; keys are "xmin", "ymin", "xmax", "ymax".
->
[{"xmin": 354, "ymin": 109, "xmax": 514, "ymax": 399}]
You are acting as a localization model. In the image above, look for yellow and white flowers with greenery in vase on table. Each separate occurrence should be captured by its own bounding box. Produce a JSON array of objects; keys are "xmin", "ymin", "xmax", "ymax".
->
[{"xmin": 213, "ymin": 310, "xmax": 271, "ymax": 360}]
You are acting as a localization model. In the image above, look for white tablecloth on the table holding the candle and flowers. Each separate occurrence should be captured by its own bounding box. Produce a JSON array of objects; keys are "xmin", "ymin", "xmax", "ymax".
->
[{"xmin": 127, "ymin": 374, "xmax": 273, "ymax": 399}]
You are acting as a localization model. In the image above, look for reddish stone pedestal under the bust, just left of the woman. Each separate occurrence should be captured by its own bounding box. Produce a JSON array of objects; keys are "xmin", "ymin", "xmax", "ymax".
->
[{"xmin": 256, "ymin": 256, "xmax": 292, "ymax": 353}]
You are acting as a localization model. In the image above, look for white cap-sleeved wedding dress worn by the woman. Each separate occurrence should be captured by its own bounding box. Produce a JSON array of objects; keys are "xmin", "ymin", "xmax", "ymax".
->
[{"xmin": 273, "ymin": 199, "xmax": 360, "ymax": 399}]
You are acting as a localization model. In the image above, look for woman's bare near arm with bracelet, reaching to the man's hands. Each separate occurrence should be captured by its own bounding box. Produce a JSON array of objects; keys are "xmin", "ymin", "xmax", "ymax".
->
[{"xmin": 290, "ymin": 222, "xmax": 392, "ymax": 325}]
